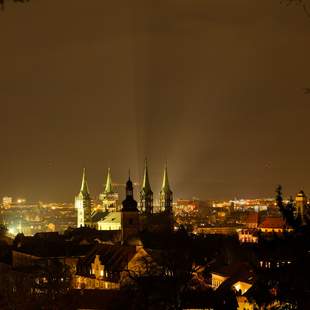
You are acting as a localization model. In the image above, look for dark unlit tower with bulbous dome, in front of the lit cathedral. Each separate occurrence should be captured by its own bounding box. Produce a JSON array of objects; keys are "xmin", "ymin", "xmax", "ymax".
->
[{"xmin": 121, "ymin": 176, "xmax": 140, "ymax": 242}]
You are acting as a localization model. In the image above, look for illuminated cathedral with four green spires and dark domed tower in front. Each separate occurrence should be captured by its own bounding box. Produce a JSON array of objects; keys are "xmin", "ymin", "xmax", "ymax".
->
[{"xmin": 75, "ymin": 160, "xmax": 173, "ymax": 241}]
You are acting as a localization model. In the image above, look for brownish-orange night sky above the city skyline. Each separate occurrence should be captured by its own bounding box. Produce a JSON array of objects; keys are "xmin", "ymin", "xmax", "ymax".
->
[{"xmin": 0, "ymin": 0, "xmax": 310, "ymax": 201}]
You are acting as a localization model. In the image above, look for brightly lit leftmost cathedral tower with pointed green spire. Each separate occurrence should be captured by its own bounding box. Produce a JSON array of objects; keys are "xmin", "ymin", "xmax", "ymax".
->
[{"xmin": 74, "ymin": 168, "xmax": 92, "ymax": 227}]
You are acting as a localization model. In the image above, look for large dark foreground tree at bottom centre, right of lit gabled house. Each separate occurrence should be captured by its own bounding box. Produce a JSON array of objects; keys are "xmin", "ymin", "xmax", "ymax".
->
[{"xmin": 123, "ymin": 228, "xmax": 205, "ymax": 309}]
